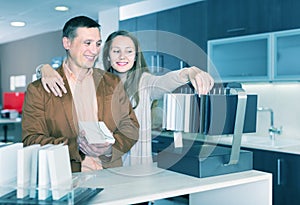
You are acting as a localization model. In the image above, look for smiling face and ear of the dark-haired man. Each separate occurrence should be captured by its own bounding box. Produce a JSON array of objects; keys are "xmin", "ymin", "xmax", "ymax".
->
[{"xmin": 63, "ymin": 27, "xmax": 101, "ymax": 69}]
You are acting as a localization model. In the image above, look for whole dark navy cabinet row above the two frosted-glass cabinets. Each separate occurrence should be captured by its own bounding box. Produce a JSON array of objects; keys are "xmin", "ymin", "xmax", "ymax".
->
[{"xmin": 208, "ymin": 0, "xmax": 300, "ymax": 39}]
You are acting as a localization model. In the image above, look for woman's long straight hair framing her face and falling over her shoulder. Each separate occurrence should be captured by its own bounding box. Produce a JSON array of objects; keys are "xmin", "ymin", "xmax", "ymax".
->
[{"xmin": 102, "ymin": 30, "xmax": 149, "ymax": 108}]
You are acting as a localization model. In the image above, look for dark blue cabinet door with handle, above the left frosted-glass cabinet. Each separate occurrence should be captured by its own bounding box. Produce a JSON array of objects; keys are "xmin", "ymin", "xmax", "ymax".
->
[{"xmin": 207, "ymin": 0, "xmax": 277, "ymax": 39}]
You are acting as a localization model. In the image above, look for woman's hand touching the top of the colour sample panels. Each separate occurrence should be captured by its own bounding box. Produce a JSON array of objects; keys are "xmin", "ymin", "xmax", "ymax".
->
[{"xmin": 180, "ymin": 66, "xmax": 214, "ymax": 95}]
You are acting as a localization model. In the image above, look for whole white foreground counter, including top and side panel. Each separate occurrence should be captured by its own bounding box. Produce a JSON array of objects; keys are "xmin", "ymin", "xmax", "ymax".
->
[{"xmin": 82, "ymin": 163, "xmax": 272, "ymax": 205}]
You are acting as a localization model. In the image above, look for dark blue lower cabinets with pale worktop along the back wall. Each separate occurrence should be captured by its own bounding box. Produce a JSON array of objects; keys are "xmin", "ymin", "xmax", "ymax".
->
[{"xmin": 152, "ymin": 132, "xmax": 300, "ymax": 205}]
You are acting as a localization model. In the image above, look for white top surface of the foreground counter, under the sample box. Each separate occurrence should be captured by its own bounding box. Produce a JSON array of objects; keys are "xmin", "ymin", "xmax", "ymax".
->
[{"xmin": 78, "ymin": 164, "xmax": 272, "ymax": 204}]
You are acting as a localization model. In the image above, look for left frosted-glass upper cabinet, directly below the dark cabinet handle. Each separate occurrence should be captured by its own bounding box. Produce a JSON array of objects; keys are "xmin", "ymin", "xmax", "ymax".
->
[{"xmin": 208, "ymin": 34, "xmax": 272, "ymax": 82}]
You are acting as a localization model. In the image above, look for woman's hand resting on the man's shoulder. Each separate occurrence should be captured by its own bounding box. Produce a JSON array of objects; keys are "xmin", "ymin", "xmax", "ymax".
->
[{"xmin": 41, "ymin": 64, "xmax": 67, "ymax": 97}]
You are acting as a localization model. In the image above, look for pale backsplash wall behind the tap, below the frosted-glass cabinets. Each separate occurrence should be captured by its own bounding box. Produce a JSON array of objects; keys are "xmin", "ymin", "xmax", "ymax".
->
[{"xmin": 243, "ymin": 83, "xmax": 300, "ymax": 140}]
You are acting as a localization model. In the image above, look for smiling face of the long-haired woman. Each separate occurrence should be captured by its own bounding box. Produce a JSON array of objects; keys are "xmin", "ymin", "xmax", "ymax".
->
[{"xmin": 109, "ymin": 36, "xmax": 136, "ymax": 73}]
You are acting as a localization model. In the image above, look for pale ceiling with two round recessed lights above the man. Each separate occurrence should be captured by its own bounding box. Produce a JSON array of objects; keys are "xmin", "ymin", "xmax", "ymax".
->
[{"xmin": 0, "ymin": 0, "xmax": 141, "ymax": 44}]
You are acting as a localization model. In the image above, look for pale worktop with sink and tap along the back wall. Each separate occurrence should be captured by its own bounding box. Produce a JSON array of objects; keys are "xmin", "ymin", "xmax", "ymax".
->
[{"xmin": 152, "ymin": 131, "xmax": 300, "ymax": 154}]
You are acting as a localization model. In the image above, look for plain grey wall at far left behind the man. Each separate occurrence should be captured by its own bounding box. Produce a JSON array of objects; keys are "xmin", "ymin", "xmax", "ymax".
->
[{"xmin": 0, "ymin": 31, "xmax": 65, "ymax": 100}]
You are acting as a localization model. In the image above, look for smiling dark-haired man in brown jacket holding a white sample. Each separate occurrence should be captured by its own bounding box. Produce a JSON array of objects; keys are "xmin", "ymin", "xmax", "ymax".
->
[{"xmin": 22, "ymin": 16, "xmax": 139, "ymax": 172}]
